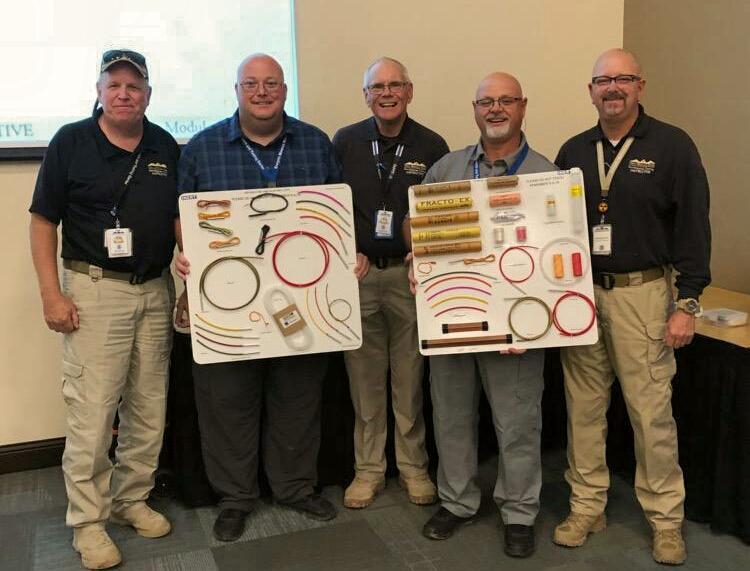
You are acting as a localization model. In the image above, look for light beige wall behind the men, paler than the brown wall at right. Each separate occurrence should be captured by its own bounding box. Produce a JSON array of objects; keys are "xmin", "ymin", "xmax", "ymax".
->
[{"xmin": 0, "ymin": 0, "xmax": 623, "ymax": 445}]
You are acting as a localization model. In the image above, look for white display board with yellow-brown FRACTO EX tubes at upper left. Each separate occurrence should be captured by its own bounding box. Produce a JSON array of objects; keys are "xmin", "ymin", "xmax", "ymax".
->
[{"xmin": 409, "ymin": 169, "xmax": 598, "ymax": 355}]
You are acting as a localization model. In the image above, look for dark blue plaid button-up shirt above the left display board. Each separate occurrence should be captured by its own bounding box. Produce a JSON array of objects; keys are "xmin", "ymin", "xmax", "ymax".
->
[{"xmin": 177, "ymin": 111, "xmax": 341, "ymax": 194}]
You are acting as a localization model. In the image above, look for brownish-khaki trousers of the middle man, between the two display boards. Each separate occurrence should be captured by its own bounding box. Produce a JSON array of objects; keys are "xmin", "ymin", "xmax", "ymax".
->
[{"xmin": 344, "ymin": 265, "xmax": 428, "ymax": 480}]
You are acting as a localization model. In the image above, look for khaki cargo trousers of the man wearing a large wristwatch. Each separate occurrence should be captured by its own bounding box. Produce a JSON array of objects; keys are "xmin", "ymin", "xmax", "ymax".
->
[{"xmin": 561, "ymin": 279, "xmax": 685, "ymax": 528}]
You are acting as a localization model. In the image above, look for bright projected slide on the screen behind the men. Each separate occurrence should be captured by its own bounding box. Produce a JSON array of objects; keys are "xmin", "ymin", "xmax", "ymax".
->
[{"xmin": 0, "ymin": 0, "xmax": 297, "ymax": 151}]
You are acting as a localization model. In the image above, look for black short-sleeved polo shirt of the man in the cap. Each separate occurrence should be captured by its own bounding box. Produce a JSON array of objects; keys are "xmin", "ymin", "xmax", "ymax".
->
[{"xmin": 29, "ymin": 110, "xmax": 180, "ymax": 278}]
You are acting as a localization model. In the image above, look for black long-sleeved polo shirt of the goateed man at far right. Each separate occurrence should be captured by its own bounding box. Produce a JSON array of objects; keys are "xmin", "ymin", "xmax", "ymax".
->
[{"xmin": 555, "ymin": 107, "xmax": 711, "ymax": 298}]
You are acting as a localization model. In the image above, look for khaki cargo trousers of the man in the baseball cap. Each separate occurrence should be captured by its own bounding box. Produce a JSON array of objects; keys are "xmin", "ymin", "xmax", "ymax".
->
[{"xmin": 62, "ymin": 270, "xmax": 174, "ymax": 527}]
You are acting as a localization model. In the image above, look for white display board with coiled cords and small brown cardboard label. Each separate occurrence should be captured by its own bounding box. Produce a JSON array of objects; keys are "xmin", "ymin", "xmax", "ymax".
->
[{"xmin": 180, "ymin": 184, "xmax": 362, "ymax": 364}]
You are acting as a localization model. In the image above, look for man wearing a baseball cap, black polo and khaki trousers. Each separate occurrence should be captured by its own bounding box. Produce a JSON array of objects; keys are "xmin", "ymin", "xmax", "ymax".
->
[{"xmin": 29, "ymin": 50, "xmax": 179, "ymax": 569}]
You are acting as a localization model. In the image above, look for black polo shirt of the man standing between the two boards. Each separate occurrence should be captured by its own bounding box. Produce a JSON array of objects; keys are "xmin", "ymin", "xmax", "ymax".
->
[{"xmin": 333, "ymin": 117, "xmax": 449, "ymax": 258}]
